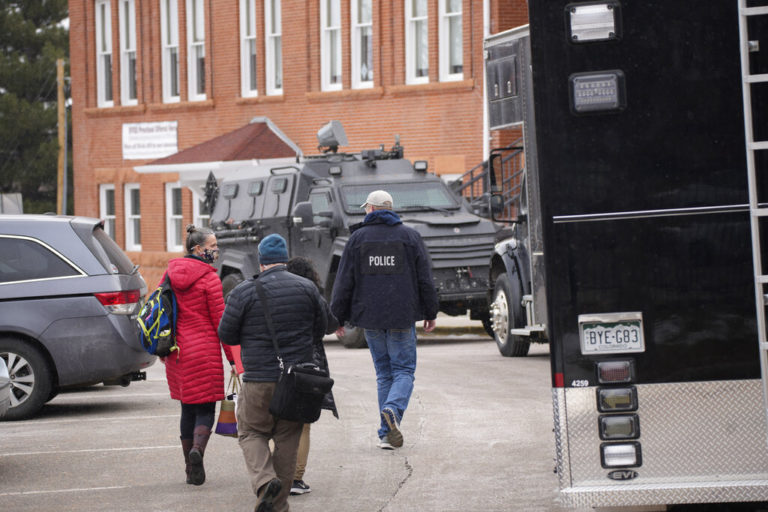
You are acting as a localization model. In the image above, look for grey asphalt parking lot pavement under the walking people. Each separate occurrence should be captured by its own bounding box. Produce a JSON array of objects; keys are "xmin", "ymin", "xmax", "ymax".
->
[{"xmin": 0, "ymin": 315, "xmax": 576, "ymax": 512}]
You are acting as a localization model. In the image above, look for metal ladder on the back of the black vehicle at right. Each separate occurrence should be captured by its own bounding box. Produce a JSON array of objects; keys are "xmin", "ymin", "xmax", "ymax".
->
[{"xmin": 738, "ymin": 0, "xmax": 768, "ymax": 440}]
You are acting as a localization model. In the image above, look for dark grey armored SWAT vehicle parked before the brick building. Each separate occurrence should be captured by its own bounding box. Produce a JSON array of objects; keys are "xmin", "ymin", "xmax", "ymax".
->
[{"xmin": 206, "ymin": 121, "xmax": 498, "ymax": 347}]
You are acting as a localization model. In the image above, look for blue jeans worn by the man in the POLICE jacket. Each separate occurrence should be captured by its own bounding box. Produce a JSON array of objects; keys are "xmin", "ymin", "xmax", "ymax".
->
[{"xmin": 365, "ymin": 326, "xmax": 416, "ymax": 438}]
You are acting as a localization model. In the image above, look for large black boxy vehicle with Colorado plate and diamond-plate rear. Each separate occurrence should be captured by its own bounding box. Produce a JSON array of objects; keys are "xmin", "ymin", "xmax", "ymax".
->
[{"xmin": 486, "ymin": 0, "xmax": 768, "ymax": 508}]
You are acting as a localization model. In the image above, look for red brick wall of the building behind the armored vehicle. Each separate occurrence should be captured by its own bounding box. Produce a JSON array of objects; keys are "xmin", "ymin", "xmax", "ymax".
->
[{"xmin": 69, "ymin": 0, "xmax": 527, "ymax": 286}]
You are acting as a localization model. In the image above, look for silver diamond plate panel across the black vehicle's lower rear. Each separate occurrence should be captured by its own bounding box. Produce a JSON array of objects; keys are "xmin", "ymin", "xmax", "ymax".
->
[{"xmin": 553, "ymin": 380, "xmax": 768, "ymax": 506}]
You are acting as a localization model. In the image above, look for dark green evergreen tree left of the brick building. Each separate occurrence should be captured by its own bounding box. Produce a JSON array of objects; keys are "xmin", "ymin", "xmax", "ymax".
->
[{"xmin": 0, "ymin": 0, "xmax": 72, "ymax": 213}]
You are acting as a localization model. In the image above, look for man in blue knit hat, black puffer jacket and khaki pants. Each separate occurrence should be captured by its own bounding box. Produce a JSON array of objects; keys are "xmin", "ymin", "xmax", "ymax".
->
[{"xmin": 219, "ymin": 234, "xmax": 328, "ymax": 512}]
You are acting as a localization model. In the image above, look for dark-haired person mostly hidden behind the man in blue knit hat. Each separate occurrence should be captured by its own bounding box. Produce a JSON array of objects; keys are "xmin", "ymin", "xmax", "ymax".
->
[{"xmin": 286, "ymin": 256, "xmax": 339, "ymax": 495}]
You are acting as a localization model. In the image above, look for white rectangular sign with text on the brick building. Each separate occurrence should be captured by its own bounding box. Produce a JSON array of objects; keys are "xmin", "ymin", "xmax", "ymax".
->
[{"xmin": 123, "ymin": 121, "xmax": 179, "ymax": 160}]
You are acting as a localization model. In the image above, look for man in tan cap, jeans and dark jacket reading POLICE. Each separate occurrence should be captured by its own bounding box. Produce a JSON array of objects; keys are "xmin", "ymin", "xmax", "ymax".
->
[{"xmin": 331, "ymin": 190, "xmax": 438, "ymax": 450}]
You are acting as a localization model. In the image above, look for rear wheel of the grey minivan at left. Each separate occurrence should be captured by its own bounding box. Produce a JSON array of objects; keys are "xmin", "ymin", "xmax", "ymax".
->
[{"xmin": 0, "ymin": 338, "xmax": 52, "ymax": 420}]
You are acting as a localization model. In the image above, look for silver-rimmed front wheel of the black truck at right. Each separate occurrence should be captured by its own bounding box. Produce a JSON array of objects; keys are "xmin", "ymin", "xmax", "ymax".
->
[{"xmin": 491, "ymin": 273, "xmax": 531, "ymax": 357}]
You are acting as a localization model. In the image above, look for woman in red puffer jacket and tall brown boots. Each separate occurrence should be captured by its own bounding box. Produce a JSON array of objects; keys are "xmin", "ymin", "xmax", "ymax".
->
[{"xmin": 160, "ymin": 225, "xmax": 234, "ymax": 485}]
